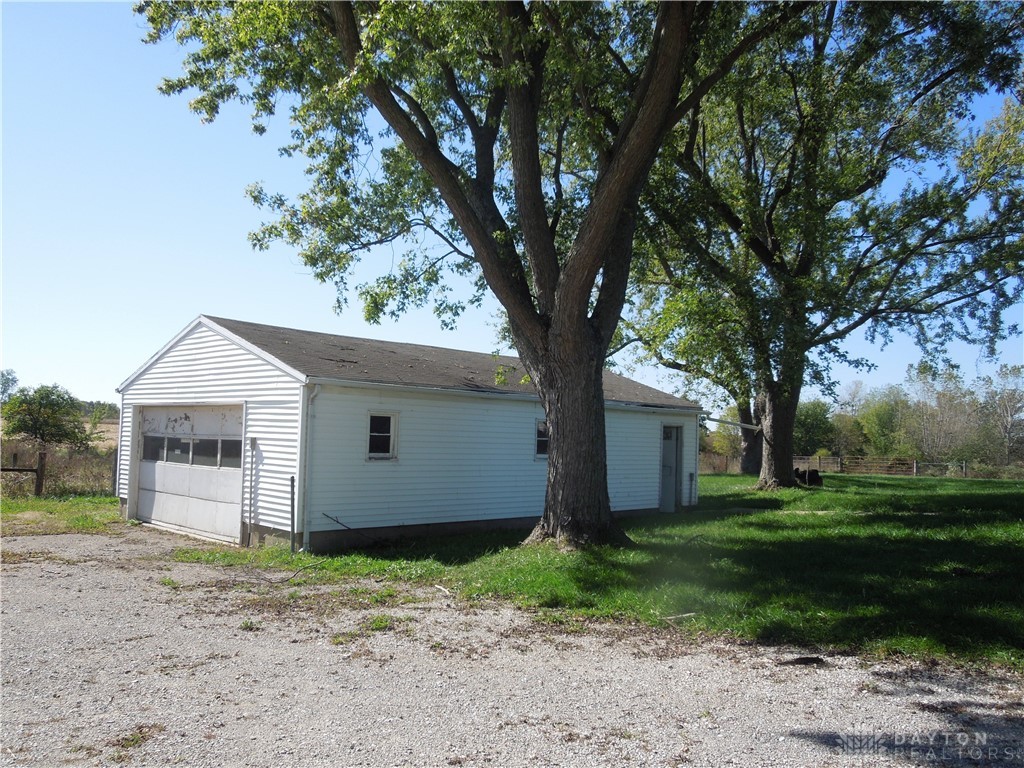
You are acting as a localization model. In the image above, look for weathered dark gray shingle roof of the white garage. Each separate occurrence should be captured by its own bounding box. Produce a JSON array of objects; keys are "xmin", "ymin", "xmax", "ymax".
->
[{"xmin": 203, "ymin": 315, "xmax": 699, "ymax": 410}]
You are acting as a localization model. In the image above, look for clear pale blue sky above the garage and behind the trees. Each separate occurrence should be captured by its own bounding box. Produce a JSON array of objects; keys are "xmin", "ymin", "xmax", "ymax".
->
[{"xmin": 0, "ymin": 2, "xmax": 1024, "ymax": 409}]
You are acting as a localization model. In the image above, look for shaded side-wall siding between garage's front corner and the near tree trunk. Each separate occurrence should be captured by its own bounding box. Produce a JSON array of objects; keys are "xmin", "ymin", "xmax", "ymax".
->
[{"xmin": 308, "ymin": 387, "xmax": 547, "ymax": 530}]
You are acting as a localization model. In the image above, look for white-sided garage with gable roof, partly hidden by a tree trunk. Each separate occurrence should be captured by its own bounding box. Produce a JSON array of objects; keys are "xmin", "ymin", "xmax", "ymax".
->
[{"xmin": 118, "ymin": 315, "xmax": 701, "ymax": 551}]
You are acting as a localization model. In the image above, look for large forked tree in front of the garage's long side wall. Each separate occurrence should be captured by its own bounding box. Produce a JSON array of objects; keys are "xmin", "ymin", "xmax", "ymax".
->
[{"xmin": 139, "ymin": 2, "xmax": 798, "ymax": 545}]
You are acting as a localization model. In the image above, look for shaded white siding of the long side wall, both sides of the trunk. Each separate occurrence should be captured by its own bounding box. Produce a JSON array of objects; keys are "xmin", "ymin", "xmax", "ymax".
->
[{"xmin": 306, "ymin": 386, "xmax": 696, "ymax": 531}]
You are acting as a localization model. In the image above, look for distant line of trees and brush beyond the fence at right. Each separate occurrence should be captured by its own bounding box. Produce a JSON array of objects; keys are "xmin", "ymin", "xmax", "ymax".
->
[{"xmin": 707, "ymin": 362, "xmax": 1024, "ymax": 466}]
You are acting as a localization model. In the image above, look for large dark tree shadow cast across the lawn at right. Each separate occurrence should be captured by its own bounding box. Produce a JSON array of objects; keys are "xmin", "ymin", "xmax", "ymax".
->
[{"xmin": 622, "ymin": 512, "xmax": 1024, "ymax": 662}]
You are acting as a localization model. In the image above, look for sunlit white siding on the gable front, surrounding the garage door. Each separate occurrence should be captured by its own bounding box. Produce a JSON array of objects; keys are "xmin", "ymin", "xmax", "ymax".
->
[{"xmin": 118, "ymin": 324, "xmax": 301, "ymax": 530}]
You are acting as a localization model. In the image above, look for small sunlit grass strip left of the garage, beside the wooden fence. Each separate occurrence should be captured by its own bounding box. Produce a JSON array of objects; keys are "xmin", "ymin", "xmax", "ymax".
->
[{"xmin": 0, "ymin": 496, "xmax": 122, "ymax": 536}]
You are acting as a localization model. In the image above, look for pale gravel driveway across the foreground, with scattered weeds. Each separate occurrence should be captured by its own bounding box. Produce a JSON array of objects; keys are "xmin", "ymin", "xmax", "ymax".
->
[{"xmin": 0, "ymin": 527, "xmax": 1024, "ymax": 768}]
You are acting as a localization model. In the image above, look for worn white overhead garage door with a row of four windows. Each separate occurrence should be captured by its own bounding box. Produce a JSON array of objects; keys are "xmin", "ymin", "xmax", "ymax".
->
[{"xmin": 136, "ymin": 406, "xmax": 242, "ymax": 542}]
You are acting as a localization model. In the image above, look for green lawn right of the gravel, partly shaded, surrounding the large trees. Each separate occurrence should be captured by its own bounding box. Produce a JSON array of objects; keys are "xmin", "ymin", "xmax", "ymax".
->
[{"xmin": 4, "ymin": 475, "xmax": 1024, "ymax": 670}]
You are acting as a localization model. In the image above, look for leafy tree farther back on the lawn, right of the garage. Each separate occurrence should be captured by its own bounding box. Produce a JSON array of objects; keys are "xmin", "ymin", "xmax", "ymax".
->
[{"xmin": 631, "ymin": 2, "xmax": 1024, "ymax": 486}]
